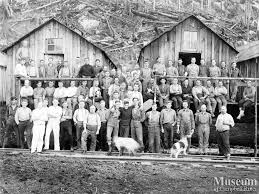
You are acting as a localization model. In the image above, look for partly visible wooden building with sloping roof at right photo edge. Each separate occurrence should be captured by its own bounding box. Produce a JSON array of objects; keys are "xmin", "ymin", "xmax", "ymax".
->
[{"xmin": 237, "ymin": 41, "xmax": 259, "ymax": 101}]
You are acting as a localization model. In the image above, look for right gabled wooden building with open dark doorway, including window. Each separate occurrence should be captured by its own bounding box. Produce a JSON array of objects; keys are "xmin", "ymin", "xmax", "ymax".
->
[{"xmin": 138, "ymin": 15, "xmax": 238, "ymax": 66}]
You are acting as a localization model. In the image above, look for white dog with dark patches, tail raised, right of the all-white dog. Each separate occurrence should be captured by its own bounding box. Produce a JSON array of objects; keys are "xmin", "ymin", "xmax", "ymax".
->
[{"xmin": 170, "ymin": 131, "xmax": 193, "ymax": 158}]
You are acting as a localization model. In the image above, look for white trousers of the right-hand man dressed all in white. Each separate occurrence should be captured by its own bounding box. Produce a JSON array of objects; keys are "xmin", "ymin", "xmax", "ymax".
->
[{"xmin": 44, "ymin": 120, "xmax": 60, "ymax": 151}]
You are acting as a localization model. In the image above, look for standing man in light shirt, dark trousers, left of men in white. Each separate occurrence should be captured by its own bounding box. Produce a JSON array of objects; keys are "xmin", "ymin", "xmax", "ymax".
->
[{"xmin": 15, "ymin": 98, "xmax": 31, "ymax": 149}]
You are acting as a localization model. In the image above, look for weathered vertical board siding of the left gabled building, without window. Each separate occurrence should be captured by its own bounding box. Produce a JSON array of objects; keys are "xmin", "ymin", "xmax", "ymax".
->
[{"xmin": 3, "ymin": 20, "xmax": 110, "ymax": 104}]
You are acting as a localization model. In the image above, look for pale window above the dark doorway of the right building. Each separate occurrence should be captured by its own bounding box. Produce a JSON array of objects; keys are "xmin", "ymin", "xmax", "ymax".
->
[{"xmin": 183, "ymin": 31, "xmax": 198, "ymax": 51}]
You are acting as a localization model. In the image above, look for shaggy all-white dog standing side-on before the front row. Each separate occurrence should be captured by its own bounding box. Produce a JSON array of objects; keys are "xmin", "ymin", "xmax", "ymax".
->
[{"xmin": 113, "ymin": 137, "xmax": 140, "ymax": 156}]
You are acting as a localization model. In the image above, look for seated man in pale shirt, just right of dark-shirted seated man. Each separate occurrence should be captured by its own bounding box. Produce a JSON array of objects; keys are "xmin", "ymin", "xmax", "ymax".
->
[{"xmin": 192, "ymin": 80, "xmax": 210, "ymax": 112}]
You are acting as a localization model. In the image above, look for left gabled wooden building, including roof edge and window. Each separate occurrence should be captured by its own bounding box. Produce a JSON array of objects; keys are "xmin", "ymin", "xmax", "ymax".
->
[{"xmin": 3, "ymin": 18, "xmax": 115, "ymax": 104}]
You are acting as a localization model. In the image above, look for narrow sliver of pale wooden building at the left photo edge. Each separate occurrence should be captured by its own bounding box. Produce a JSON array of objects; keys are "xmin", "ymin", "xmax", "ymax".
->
[{"xmin": 0, "ymin": 52, "xmax": 7, "ymax": 104}]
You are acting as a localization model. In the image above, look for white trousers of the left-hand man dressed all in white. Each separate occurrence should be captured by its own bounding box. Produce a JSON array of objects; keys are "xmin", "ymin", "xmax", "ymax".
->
[{"xmin": 31, "ymin": 124, "xmax": 45, "ymax": 153}]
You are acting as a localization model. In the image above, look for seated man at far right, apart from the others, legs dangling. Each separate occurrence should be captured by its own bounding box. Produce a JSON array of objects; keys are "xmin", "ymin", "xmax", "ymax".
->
[{"xmin": 237, "ymin": 81, "xmax": 255, "ymax": 119}]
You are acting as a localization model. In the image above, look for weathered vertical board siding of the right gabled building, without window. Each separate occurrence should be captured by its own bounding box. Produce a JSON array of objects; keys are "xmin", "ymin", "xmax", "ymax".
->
[{"xmin": 139, "ymin": 17, "xmax": 240, "ymax": 65}]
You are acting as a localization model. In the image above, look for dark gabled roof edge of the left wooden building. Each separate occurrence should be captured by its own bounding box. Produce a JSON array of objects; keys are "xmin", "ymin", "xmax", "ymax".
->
[{"xmin": 2, "ymin": 18, "xmax": 115, "ymax": 66}]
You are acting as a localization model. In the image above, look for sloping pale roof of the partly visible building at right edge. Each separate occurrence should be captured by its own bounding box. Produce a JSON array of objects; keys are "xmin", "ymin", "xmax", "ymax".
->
[{"xmin": 237, "ymin": 41, "xmax": 259, "ymax": 62}]
